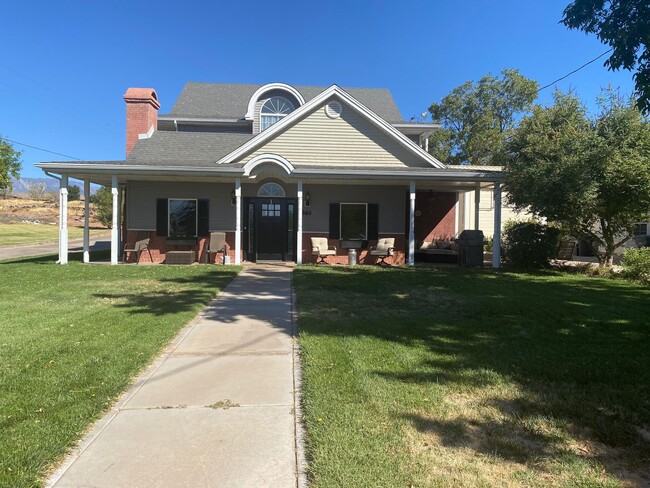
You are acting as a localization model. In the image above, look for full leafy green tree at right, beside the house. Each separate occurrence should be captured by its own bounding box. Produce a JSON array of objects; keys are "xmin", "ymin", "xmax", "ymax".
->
[{"xmin": 506, "ymin": 91, "xmax": 650, "ymax": 266}]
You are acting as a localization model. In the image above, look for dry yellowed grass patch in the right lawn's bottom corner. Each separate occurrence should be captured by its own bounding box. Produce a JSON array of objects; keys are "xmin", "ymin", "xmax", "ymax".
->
[{"xmin": 405, "ymin": 387, "xmax": 650, "ymax": 487}]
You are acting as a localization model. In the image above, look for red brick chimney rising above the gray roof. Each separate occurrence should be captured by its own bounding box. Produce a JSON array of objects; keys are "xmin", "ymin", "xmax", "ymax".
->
[{"xmin": 124, "ymin": 88, "xmax": 160, "ymax": 156}]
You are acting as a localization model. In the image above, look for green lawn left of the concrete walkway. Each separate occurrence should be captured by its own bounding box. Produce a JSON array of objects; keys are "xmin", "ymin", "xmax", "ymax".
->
[{"xmin": 0, "ymin": 256, "xmax": 239, "ymax": 487}]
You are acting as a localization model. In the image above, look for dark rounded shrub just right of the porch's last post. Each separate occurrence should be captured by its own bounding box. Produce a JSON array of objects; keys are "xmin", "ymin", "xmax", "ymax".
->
[{"xmin": 503, "ymin": 220, "xmax": 560, "ymax": 268}]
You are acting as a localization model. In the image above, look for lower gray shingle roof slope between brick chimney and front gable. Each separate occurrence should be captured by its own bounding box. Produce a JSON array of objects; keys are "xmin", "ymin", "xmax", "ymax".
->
[{"xmin": 127, "ymin": 131, "xmax": 253, "ymax": 166}]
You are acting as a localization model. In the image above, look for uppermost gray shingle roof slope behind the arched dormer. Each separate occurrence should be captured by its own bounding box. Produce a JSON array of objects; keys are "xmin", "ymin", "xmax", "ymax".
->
[{"xmin": 168, "ymin": 82, "xmax": 404, "ymax": 123}]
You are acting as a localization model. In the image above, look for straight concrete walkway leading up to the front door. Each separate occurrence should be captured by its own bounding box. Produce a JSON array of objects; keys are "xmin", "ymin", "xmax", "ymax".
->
[{"xmin": 47, "ymin": 266, "xmax": 304, "ymax": 488}]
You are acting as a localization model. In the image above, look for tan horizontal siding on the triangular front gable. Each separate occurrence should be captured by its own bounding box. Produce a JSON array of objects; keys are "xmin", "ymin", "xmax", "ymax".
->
[{"xmin": 241, "ymin": 97, "xmax": 431, "ymax": 167}]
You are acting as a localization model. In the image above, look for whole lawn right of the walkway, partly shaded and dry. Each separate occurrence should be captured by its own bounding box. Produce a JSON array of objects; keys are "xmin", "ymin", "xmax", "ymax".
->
[{"xmin": 294, "ymin": 266, "xmax": 650, "ymax": 488}]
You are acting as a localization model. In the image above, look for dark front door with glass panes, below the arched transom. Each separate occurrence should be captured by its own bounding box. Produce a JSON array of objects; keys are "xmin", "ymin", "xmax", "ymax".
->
[{"xmin": 244, "ymin": 198, "xmax": 296, "ymax": 261}]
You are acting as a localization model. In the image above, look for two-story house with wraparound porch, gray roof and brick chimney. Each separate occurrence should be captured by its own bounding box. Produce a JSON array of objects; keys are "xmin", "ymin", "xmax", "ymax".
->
[{"xmin": 37, "ymin": 83, "xmax": 503, "ymax": 267}]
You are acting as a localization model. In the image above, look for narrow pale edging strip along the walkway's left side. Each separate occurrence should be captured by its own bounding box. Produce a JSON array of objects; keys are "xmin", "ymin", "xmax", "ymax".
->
[{"xmin": 41, "ymin": 276, "xmax": 236, "ymax": 488}]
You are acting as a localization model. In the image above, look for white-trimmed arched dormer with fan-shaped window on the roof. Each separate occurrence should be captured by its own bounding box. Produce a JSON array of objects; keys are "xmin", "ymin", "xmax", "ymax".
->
[{"xmin": 244, "ymin": 83, "xmax": 305, "ymax": 134}]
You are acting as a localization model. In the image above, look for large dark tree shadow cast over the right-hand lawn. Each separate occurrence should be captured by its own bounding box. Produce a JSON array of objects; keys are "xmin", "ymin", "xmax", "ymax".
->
[{"xmin": 294, "ymin": 268, "xmax": 650, "ymax": 483}]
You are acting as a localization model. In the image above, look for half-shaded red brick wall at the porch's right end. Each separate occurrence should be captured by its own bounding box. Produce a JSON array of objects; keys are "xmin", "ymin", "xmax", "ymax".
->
[{"xmin": 415, "ymin": 192, "xmax": 456, "ymax": 244}]
